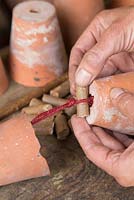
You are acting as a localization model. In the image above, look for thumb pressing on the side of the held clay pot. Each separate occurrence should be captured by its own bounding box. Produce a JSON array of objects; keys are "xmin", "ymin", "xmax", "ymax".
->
[{"xmin": 110, "ymin": 88, "xmax": 134, "ymax": 120}]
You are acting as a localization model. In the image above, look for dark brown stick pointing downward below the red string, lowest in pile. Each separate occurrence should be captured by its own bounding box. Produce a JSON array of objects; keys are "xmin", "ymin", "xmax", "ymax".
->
[{"xmin": 55, "ymin": 113, "xmax": 70, "ymax": 140}]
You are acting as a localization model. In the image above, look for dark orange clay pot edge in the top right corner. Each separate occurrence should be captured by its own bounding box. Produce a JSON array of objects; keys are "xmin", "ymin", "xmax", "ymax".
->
[{"xmin": 110, "ymin": 0, "xmax": 134, "ymax": 8}]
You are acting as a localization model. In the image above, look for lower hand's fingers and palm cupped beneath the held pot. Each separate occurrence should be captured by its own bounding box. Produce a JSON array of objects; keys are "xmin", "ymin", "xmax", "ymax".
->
[{"xmin": 72, "ymin": 116, "xmax": 134, "ymax": 187}]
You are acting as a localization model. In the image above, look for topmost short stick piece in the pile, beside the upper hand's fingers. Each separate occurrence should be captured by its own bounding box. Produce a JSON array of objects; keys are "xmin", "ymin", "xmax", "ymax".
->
[{"xmin": 50, "ymin": 80, "xmax": 70, "ymax": 97}]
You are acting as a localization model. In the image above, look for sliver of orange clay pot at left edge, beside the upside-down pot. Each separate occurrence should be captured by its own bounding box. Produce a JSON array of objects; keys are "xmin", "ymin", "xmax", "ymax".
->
[{"xmin": 0, "ymin": 58, "xmax": 8, "ymax": 95}]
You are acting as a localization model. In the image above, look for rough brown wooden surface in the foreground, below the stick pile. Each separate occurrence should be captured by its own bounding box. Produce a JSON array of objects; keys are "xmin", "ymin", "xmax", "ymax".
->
[{"xmin": 0, "ymin": 135, "xmax": 134, "ymax": 200}]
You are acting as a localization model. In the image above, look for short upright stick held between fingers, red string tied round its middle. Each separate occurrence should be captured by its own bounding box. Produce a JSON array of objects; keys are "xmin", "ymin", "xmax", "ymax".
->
[{"xmin": 76, "ymin": 86, "xmax": 89, "ymax": 117}]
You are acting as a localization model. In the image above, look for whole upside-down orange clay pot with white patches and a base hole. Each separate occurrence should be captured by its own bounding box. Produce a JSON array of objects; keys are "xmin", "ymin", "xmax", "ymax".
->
[{"xmin": 10, "ymin": 1, "xmax": 67, "ymax": 87}]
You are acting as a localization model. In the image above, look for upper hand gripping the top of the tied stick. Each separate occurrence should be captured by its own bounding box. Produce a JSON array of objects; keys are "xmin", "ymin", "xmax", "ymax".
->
[{"xmin": 69, "ymin": 7, "xmax": 134, "ymax": 94}]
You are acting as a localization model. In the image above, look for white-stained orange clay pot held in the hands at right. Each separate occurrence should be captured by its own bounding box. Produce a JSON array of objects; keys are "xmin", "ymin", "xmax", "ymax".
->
[{"xmin": 87, "ymin": 72, "xmax": 134, "ymax": 135}]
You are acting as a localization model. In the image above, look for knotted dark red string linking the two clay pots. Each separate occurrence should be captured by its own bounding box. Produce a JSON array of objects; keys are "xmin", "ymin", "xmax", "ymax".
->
[{"xmin": 31, "ymin": 96, "xmax": 94, "ymax": 125}]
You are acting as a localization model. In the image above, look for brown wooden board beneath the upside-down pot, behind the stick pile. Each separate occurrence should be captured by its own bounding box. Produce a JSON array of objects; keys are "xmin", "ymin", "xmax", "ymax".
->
[{"xmin": 0, "ymin": 74, "xmax": 67, "ymax": 119}]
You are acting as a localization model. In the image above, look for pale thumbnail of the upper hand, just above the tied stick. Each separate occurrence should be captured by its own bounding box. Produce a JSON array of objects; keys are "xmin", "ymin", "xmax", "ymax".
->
[{"xmin": 75, "ymin": 69, "xmax": 93, "ymax": 86}]
